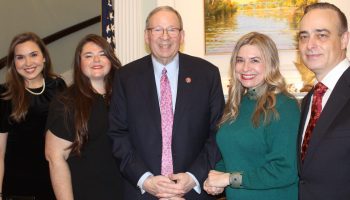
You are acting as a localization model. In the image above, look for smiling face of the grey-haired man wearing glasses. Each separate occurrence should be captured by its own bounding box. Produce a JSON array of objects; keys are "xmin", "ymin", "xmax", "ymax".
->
[{"xmin": 145, "ymin": 10, "xmax": 184, "ymax": 65}]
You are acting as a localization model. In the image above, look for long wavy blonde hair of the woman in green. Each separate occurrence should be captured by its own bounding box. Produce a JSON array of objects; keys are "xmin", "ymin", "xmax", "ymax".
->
[{"xmin": 219, "ymin": 32, "xmax": 292, "ymax": 127}]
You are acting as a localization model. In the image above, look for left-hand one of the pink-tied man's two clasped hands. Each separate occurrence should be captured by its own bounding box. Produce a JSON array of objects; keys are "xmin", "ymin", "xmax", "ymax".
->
[{"xmin": 143, "ymin": 175, "xmax": 185, "ymax": 199}]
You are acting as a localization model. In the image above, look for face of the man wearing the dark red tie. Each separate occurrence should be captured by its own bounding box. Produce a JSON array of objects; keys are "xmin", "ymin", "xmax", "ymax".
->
[{"xmin": 299, "ymin": 9, "xmax": 348, "ymax": 81}]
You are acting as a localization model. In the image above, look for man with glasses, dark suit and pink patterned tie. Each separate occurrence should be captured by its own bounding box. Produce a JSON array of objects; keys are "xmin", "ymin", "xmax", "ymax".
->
[{"xmin": 108, "ymin": 6, "xmax": 224, "ymax": 200}]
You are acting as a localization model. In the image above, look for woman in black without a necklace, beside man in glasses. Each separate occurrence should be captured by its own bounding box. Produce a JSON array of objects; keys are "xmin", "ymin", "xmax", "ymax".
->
[{"xmin": 45, "ymin": 34, "xmax": 122, "ymax": 200}]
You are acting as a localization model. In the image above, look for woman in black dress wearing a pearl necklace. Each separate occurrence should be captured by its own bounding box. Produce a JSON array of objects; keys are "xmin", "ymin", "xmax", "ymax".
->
[{"xmin": 0, "ymin": 32, "xmax": 66, "ymax": 200}]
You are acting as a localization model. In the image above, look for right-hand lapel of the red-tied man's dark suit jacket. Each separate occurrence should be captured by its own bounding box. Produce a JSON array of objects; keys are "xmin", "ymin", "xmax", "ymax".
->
[{"xmin": 303, "ymin": 68, "xmax": 350, "ymax": 168}]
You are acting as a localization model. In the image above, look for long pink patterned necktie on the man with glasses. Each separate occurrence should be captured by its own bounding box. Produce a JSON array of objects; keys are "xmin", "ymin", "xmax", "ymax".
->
[{"xmin": 160, "ymin": 68, "xmax": 174, "ymax": 175}]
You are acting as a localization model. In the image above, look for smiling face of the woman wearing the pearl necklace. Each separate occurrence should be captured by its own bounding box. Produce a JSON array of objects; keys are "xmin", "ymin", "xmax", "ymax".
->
[{"xmin": 14, "ymin": 41, "xmax": 45, "ymax": 86}]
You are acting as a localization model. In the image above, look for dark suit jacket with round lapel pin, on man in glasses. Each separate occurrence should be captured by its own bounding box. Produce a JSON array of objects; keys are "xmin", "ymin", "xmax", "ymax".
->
[{"xmin": 109, "ymin": 53, "xmax": 224, "ymax": 199}]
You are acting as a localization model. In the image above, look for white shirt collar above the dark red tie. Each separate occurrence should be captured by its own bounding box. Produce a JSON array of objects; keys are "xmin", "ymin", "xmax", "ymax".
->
[{"xmin": 316, "ymin": 58, "xmax": 350, "ymax": 91}]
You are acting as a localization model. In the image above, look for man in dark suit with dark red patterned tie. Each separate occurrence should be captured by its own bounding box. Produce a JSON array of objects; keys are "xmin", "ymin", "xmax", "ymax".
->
[{"xmin": 298, "ymin": 3, "xmax": 350, "ymax": 200}]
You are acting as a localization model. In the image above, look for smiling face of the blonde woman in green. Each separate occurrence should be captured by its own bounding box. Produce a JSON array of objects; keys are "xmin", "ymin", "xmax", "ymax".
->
[{"xmin": 234, "ymin": 45, "xmax": 266, "ymax": 88}]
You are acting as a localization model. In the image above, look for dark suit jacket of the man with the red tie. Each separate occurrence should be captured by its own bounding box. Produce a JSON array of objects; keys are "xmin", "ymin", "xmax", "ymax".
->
[{"xmin": 298, "ymin": 68, "xmax": 350, "ymax": 200}]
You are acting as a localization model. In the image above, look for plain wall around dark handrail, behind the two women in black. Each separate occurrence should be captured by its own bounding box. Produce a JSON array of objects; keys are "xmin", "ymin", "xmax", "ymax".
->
[{"xmin": 0, "ymin": 0, "xmax": 101, "ymax": 83}]
